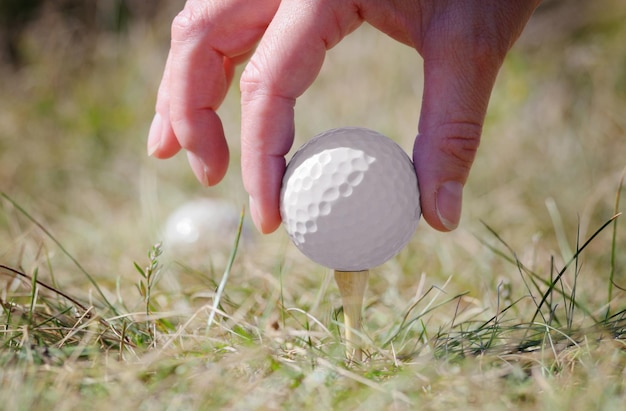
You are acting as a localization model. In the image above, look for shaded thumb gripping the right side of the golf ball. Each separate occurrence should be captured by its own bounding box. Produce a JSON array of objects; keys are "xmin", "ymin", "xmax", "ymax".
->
[{"xmin": 413, "ymin": 47, "xmax": 501, "ymax": 231}]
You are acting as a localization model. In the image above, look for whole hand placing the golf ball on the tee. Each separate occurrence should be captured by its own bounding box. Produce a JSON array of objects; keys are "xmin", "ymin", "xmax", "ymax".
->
[{"xmin": 148, "ymin": 0, "xmax": 539, "ymax": 233}]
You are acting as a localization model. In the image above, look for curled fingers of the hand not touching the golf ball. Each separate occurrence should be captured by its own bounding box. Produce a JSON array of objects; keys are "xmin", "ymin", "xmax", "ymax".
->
[{"xmin": 156, "ymin": 0, "xmax": 278, "ymax": 185}]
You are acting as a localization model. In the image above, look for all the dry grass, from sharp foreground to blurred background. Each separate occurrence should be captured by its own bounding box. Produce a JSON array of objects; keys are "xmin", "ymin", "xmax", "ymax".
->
[{"xmin": 0, "ymin": 0, "xmax": 626, "ymax": 410}]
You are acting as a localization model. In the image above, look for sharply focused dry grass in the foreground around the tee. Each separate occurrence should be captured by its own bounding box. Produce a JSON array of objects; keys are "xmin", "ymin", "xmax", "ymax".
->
[{"xmin": 0, "ymin": 192, "xmax": 626, "ymax": 409}]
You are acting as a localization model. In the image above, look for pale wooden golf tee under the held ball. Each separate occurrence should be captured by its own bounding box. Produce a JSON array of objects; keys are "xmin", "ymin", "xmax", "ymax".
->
[{"xmin": 335, "ymin": 270, "xmax": 369, "ymax": 362}]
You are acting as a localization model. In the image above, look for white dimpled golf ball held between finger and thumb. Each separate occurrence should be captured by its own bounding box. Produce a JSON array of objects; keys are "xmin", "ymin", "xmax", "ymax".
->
[{"xmin": 280, "ymin": 127, "xmax": 421, "ymax": 271}]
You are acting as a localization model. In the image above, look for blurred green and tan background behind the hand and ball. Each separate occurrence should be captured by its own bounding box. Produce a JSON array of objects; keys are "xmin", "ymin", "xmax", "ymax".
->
[{"xmin": 0, "ymin": 0, "xmax": 626, "ymax": 302}]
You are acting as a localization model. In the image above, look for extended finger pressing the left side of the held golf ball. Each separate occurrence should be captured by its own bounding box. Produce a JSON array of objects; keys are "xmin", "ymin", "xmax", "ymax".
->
[{"xmin": 241, "ymin": 0, "xmax": 361, "ymax": 233}]
